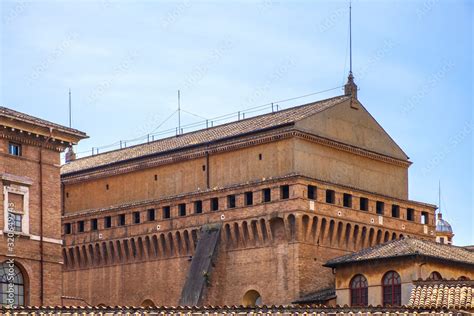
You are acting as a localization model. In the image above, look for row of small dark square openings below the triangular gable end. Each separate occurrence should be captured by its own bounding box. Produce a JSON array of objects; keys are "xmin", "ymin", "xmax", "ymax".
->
[{"xmin": 308, "ymin": 185, "xmax": 429, "ymax": 224}]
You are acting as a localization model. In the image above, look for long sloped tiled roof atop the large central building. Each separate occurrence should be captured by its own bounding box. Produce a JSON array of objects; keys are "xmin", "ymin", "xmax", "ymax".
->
[{"xmin": 61, "ymin": 96, "xmax": 350, "ymax": 174}]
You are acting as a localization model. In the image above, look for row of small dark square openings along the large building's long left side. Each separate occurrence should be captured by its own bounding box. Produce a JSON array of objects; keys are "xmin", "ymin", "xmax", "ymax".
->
[{"xmin": 64, "ymin": 185, "xmax": 290, "ymax": 234}]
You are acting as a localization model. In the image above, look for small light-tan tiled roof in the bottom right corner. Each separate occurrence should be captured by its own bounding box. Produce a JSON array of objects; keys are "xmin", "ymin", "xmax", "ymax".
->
[{"xmin": 408, "ymin": 281, "xmax": 474, "ymax": 310}]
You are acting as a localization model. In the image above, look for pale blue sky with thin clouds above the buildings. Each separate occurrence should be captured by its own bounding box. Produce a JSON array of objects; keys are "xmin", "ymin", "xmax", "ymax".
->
[{"xmin": 0, "ymin": 0, "xmax": 474, "ymax": 245}]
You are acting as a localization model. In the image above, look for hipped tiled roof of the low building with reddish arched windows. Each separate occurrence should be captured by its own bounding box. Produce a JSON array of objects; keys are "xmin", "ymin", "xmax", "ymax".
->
[{"xmin": 325, "ymin": 237, "xmax": 474, "ymax": 267}]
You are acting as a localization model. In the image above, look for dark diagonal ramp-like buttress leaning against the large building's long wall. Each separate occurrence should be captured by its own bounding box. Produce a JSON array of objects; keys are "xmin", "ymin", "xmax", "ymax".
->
[{"xmin": 178, "ymin": 224, "xmax": 222, "ymax": 306}]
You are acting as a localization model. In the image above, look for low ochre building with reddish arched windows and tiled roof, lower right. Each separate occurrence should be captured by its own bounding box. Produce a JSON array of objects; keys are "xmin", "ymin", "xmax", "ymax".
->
[{"xmin": 325, "ymin": 238, "xmax": 474, "ymax": 308}]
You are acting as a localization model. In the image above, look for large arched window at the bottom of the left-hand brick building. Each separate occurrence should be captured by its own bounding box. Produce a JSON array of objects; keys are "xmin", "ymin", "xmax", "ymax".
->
[{"xmin": 0, "ymin": 261, "xmax": 25, "ymax": 306}]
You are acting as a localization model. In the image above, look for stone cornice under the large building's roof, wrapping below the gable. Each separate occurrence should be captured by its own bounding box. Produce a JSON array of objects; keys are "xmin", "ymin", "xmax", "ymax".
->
[{"xmin": 61, "ymin": 126, "xmax": 411, "ymax": 184}]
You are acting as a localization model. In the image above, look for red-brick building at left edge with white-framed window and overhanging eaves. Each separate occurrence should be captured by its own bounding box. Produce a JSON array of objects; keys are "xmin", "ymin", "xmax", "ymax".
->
[{"xmin": 0, "ymin": 107, "xmax": 86, "ymax": 305}]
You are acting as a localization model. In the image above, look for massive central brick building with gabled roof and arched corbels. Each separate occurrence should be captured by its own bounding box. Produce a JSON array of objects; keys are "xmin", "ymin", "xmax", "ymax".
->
[{"xmin": 61, "ymin": 77, "xmax": 436, "ymax": 305}]
